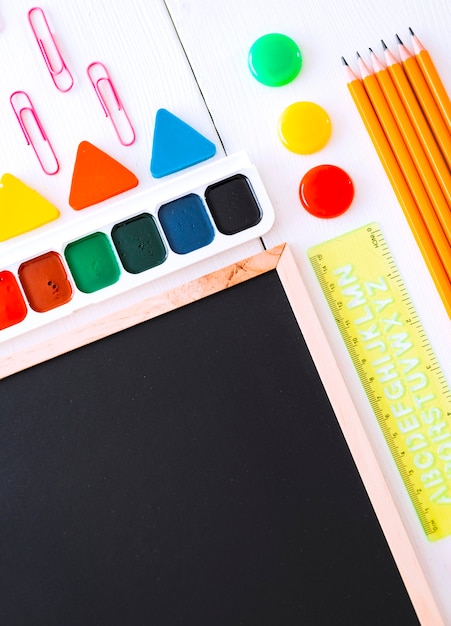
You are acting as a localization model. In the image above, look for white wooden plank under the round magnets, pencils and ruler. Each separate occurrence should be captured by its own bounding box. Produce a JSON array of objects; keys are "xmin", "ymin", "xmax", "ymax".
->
[{"xmin": 167, "ymin": 0, "xmax": 451, "ymax": 624}]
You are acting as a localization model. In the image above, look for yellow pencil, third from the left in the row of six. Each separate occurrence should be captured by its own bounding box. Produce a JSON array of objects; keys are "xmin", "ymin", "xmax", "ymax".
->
[{"xmin": 370, "ymin": 49, "xmax": 451, "ymax": 245}]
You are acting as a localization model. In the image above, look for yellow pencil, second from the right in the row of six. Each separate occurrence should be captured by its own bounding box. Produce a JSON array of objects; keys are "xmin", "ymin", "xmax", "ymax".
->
[{"xmin": 396, "ymin": 35, "xmax": 451, "ymax": 168}]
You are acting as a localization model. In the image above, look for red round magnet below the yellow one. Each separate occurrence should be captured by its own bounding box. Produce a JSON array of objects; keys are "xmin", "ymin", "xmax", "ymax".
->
[{"xmin": 299, "ymin": 165, "xmax": 354, "ymax": 218}]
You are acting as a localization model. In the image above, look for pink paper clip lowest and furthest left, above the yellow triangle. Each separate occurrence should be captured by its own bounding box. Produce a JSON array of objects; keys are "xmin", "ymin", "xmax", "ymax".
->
[{"xmin": 9, "ymin": 91, "xmax": 59, "ymax": 175}]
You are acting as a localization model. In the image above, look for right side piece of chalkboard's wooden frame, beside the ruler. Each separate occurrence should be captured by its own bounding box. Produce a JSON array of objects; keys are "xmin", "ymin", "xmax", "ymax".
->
[{"xmin": 277, "ymin": 247, "xmax": 445, "ymax": 626}]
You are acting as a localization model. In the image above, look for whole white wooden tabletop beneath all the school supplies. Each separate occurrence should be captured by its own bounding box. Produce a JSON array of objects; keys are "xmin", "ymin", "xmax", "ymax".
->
[{"xmin": 0, "ymin": 0, "xmax": 451, "ymax": 626}]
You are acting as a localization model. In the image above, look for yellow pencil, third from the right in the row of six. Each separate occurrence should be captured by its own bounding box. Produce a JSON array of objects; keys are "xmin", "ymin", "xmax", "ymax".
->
[{"xmin": 382, "ymin": 42, "xmax": 451, "ymax": 204}]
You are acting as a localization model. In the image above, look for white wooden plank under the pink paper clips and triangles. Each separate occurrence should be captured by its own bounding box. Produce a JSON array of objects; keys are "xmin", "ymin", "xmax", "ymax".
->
[{"xmin": 0, "ymin": 0, "xmax": 263, "ymax": 358}]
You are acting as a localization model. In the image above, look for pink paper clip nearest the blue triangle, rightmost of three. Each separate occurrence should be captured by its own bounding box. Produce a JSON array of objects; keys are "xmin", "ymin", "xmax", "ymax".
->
[{"xmin": 87, "ymin": 61, "xmax": 136, "ymax": 146}]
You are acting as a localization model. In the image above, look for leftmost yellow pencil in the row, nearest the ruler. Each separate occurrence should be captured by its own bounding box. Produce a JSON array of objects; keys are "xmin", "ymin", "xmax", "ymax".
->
[{"xmin": 342, "ymin": 59, "xmax": 451, "ymax": 317}]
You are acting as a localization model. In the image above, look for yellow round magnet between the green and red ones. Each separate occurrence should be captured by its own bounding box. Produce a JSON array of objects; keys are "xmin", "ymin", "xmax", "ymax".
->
[{"xmin": 278, "ymin": 102, "xmax": 332, "ymax": 154}]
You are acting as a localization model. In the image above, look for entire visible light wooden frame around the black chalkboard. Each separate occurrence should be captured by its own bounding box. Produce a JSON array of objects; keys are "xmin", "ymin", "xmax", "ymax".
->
[{"xmin": 0, "ymin": 244, "xmax": 442, "ymax": 625}]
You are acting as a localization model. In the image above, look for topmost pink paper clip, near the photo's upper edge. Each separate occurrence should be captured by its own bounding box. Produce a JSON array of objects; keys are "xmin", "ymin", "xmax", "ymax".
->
[{"xmin": 28, "ymin": 7, "xmax": 74, "ymax": 92}]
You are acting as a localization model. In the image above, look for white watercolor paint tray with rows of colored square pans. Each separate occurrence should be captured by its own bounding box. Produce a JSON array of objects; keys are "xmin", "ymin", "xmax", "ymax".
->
[{"xmin": 0, "ymin": 153, "xmax": 274, "ymax": 342}]
